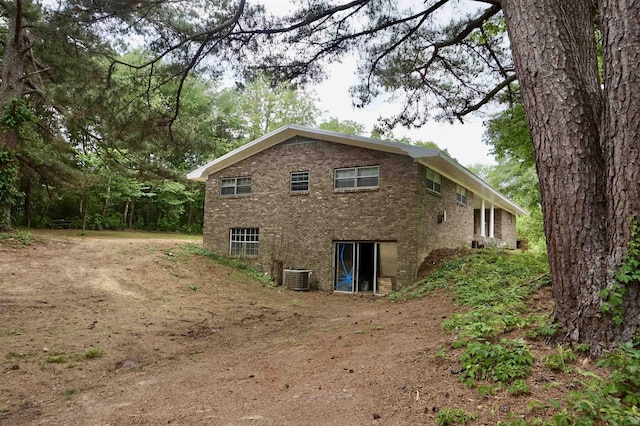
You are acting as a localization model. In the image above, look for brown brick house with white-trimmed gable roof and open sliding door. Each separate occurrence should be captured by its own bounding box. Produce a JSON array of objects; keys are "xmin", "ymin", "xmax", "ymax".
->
[{"xmin": 187, "ymin": 125, "xmax": 526, "ymax": 293}]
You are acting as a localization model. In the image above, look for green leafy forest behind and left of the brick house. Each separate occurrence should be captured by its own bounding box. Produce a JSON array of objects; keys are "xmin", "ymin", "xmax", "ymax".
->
[{"xmin": 5, "ymin": 75, "xmax": 364, "ymax": 233}]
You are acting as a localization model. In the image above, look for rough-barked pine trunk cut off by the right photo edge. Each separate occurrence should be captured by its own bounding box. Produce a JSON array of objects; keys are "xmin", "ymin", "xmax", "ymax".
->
[{"xmin": 599, "ymin": 0, "xmax": 640, "ymax": 341}]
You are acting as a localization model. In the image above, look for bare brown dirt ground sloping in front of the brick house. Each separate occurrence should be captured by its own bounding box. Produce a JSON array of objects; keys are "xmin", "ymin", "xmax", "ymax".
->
[{"xmin": 0, "ymin": 233, "xmax": 584, "ymax": 425}]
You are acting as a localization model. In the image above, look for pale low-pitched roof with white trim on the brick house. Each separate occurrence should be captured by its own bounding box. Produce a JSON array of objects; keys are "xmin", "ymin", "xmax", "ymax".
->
[{"xmin": 187, "ymin": 124, "xmax": 527, "ymax": 216}]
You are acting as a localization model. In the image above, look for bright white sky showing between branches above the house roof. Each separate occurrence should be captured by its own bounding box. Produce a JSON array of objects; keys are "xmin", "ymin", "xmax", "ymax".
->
[{"xmin": 263, "ymin": 0, "xmax": 495, "ymax": 166}]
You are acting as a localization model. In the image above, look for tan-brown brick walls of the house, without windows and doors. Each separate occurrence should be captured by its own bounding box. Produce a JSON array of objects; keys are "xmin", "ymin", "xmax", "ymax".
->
[{"xmin": 204, "ymin": 141, "xmax": 515, "ymax": 291}]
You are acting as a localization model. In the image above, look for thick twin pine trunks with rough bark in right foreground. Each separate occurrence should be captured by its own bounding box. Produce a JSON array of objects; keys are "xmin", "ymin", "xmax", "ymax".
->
[{"xmin": 503, "ymin": 0, "xmax": 640, "ymax": 353}]
